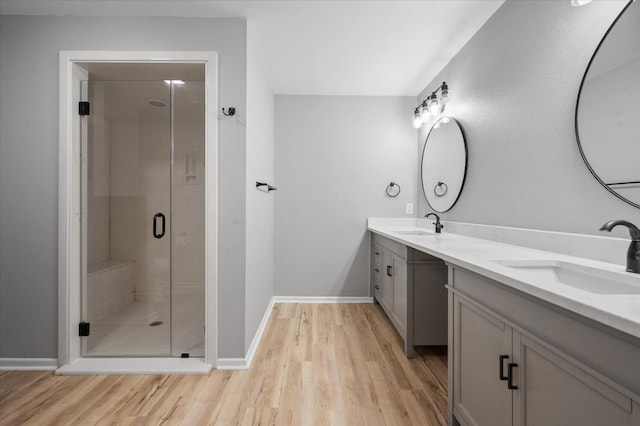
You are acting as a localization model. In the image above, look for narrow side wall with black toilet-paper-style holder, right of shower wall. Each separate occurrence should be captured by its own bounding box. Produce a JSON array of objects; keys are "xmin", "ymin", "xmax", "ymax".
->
[{"xmin": 245, "ymin": 21, "xmax": 277, "ymax": 351}]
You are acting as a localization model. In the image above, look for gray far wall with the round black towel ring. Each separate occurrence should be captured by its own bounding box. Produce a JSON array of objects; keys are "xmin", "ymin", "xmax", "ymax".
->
[{"xmin": 275, "ymin": 95, "xmax": 417, "ymax": 296}]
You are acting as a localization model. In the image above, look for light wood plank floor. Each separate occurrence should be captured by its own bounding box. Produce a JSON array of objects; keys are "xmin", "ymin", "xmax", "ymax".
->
[{"xmin": 0, "ymin": 304, "xmax": 447, "ymax": 426}]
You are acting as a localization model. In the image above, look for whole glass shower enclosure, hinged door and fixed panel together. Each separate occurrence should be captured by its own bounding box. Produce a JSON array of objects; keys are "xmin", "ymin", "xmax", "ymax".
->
[{"xmin": 80, "ymin": 76, "xmax": 205, "ymax": 357}]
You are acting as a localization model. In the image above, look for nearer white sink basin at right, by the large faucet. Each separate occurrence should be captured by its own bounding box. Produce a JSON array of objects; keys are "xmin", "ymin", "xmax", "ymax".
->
[{"xmin": 494, "ymin": 260, "xmax": 640, "ymax": 295}]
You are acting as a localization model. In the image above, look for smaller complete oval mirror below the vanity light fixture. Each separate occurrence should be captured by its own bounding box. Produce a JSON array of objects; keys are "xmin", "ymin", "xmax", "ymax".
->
[{"xmin": 421, "ymin": 117, "xmax": 467, "ymax": 213}]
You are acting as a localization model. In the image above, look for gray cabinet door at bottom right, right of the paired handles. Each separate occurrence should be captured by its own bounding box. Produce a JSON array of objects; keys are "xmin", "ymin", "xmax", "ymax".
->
[{"xmin": 512, "ymin": 332, "xmax": 632, "ymax": 426}]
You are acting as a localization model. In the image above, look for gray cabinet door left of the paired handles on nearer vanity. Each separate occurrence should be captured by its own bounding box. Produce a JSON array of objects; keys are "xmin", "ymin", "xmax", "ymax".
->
[{"xmin": 453, "ymin": 295, "xmax": 512, "ymax": 426}]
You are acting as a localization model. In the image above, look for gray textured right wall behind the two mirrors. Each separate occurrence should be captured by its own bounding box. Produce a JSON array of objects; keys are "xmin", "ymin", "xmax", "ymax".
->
[{"xmin": 418, "ymin": 0, "xmax": 640, "ymax": 236}]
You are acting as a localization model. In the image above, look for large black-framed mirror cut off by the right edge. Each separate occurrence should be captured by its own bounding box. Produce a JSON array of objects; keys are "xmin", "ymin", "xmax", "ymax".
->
[{"xmin": 575, "ymin": 1, "xmax": 640, "ymax": 208}]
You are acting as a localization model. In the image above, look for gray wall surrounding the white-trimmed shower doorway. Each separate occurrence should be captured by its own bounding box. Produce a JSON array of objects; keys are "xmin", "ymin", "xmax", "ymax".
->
[{"xmin": 0, "ymin": 16, "xmax": 246, "ymax": 358}]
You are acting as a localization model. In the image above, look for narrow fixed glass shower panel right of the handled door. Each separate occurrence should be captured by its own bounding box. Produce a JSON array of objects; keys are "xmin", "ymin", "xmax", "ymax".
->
[{"xmin": 171, "ymin": 80, "xmax": 205, "ymax": 357}]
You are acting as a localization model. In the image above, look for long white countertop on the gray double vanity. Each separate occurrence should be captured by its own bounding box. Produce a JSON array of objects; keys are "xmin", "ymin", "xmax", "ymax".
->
[{"xmin": 368, "ymin": 219, "xmax": 640, "ymax": 338}]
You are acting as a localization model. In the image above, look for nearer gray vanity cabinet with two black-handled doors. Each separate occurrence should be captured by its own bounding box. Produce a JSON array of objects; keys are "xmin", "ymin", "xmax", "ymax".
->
[{"xmin": 449, "ymin": 267, "xmax": 640, "ymax": 426}]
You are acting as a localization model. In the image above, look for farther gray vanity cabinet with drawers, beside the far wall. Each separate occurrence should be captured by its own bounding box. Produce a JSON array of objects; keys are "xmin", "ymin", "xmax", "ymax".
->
[{"xmin": 371, "ymin": 234, "xmax": 447, "ymax": 357}]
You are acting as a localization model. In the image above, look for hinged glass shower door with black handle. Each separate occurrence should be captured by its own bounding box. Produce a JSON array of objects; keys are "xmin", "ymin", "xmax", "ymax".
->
[{"xmin": 81, "ymin": 81, "xmax": 172, "ymax": 357}]
